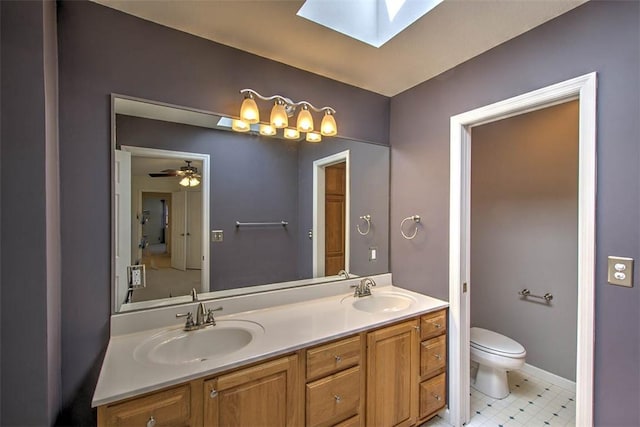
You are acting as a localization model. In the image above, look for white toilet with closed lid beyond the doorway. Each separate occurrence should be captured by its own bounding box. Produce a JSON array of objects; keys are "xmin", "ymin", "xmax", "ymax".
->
[{"xmin": 470, "ymin": 327, "xmax": 527, "ymax": 399}]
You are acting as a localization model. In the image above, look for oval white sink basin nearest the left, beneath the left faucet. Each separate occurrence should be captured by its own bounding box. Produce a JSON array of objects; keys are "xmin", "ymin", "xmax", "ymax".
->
[{"xmin": 133, "ymin": 320, "xmax": 264, "ymax": 365}]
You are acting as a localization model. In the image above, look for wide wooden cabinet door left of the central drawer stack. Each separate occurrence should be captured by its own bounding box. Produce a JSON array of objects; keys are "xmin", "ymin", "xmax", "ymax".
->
[{"xmin": 204, "ymin": 355, "xmax": 301, "ymax": 427}]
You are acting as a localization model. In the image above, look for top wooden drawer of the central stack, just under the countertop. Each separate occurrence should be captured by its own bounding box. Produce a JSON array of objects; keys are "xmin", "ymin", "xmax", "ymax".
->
[{"xmin": 307, "ymin": 335, "xmax": 361, "ymax": 379}]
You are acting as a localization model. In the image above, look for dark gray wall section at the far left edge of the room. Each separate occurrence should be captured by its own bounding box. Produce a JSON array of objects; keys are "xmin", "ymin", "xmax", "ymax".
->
[{"xmin": 0, "ymin": 2, "xmax": 61, "ymax": 425}]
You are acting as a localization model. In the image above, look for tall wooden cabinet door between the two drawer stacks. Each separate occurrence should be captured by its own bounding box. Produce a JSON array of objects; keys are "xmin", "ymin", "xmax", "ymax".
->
[{"xmin": 366, "ymin": 320, "xmax": 419, "ymax": 427}]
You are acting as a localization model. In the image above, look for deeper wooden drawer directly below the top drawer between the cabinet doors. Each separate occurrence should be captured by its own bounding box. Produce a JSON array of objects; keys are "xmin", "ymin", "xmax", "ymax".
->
[{"xmin": 307, "ymin": 366, "xmax": 360, "ymax": 426}]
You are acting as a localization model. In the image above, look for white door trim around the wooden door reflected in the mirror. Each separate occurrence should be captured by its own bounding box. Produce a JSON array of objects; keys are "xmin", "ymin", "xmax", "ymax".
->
[{"xmin": 312, "ymin": 150, "xmax": 351, "ymax": 277}]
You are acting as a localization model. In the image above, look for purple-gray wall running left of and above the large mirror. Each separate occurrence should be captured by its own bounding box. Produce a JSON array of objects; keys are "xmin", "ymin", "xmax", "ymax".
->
[{"xmin": 58, "ymin": 1, "xmax": 389, "ymax": 425}]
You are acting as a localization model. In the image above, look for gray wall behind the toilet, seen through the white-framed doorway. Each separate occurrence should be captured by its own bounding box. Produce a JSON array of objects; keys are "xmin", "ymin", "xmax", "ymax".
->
[{"xmin": 470, "ymin": 101, "xmax": 578, "ymax": 381}]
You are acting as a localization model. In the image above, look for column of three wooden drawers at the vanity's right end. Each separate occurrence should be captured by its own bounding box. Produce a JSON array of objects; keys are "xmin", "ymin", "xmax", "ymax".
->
[{"xmin": 418, "ymin": 309, "xmax": 447, "ymax": 422}]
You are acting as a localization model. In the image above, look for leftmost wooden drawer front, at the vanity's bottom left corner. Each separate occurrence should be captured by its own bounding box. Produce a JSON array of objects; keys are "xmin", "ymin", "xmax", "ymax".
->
[{"xmin": 104, "ymin": 384, "xmax": 191, "ymax": 427}]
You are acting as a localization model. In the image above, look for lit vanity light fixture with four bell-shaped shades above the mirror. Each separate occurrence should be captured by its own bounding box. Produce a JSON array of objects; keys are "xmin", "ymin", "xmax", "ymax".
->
[{"xmin": 233, "ymin": 89, "xmax": 338, "ymax": 142}]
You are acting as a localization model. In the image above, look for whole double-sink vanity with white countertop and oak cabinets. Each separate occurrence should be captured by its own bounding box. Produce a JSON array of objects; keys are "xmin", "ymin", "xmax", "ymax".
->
[{"xmin": 93, "ymin": 274, "xmax": 448, "ymax": 427}]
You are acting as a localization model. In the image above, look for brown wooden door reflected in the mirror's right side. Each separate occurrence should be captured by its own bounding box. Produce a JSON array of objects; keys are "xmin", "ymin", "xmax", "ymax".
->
[{"xmin": 324, "ymin": 162, "xmax": 346, "ymax": 276}]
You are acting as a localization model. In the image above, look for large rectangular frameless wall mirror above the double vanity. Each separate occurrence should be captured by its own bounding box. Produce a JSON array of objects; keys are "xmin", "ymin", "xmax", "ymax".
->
[{"xmin": 112, "ymin": 95, "xmax": 389, "ymax": 312}]
